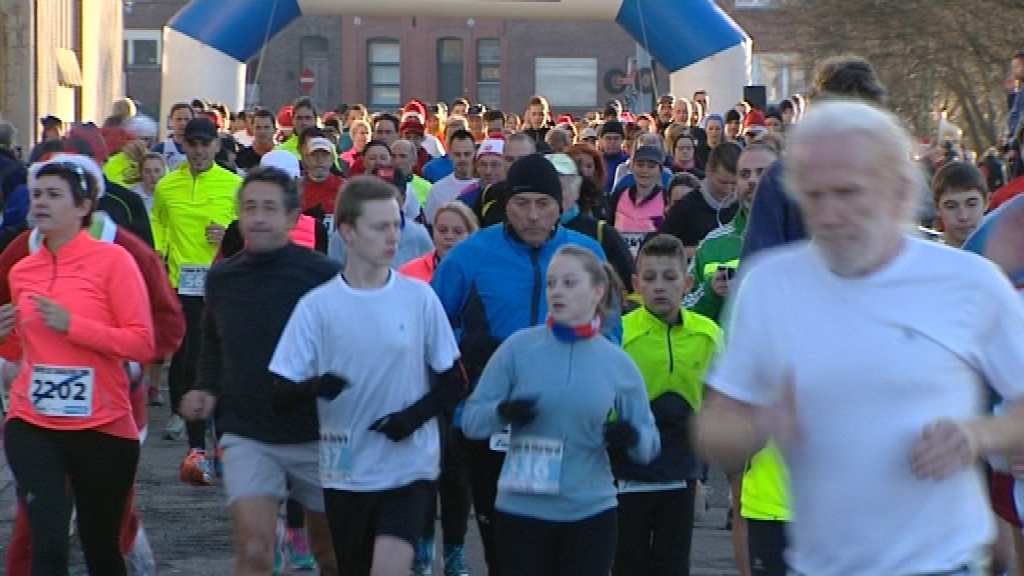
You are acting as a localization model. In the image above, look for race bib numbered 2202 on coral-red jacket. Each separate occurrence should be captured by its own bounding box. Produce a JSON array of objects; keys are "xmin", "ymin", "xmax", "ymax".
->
[{"xmin": 29, "ymin": 364, "xmax": 93, "ymax": 418}]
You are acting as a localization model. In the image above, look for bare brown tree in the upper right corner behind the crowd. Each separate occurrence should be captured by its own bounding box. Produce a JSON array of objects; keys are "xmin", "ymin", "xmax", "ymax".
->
[{"xmin": 785, "ymin": 0, "xmax": 1024, "ymax": 151}]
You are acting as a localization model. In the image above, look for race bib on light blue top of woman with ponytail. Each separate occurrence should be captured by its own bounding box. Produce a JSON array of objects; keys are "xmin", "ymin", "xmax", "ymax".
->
[{"xmin": 498, "ymin": 437, "xmax": 562, "ymax": 495}]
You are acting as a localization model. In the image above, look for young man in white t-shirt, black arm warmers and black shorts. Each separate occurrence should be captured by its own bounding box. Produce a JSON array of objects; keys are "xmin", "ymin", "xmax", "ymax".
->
[{"xmin": 269, "ymin": 175, "xmax": 469, "ymax": 576}]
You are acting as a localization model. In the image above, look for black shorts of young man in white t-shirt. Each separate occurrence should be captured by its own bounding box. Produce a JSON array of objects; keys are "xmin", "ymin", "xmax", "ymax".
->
[{"xmin": 324, "ymin": 481, "xmax": 437, "ymax": 576}]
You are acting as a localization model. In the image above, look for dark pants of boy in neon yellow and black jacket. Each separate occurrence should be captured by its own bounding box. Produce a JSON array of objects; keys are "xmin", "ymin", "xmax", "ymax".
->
[{"xmin": 614, "ymin": 482, "xmax": 696, "ymax": 576}]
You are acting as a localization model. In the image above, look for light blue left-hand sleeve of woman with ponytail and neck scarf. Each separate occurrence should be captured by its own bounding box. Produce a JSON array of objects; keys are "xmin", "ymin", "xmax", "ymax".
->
[{"xmin": 462, "ymin": 339, "xmax": 515, "ymax": 440}]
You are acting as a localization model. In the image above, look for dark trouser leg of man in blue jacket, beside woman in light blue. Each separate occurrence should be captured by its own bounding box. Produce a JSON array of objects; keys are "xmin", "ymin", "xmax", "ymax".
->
[{"xmin": 457, "ymin": 430, "xmax": 505, "ymax": 576}]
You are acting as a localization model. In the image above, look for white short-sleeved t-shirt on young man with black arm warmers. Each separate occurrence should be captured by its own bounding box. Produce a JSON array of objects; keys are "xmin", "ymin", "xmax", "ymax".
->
[{"xmin": 269, "ymin": 271, "xmax": 459, "ymax": 492}]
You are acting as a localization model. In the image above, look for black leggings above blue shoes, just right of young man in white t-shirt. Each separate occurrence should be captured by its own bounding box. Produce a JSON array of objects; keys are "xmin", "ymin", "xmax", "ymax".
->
[{"xmin": 423, "ymin": 420, "xmax": 471, "ymax": 546}]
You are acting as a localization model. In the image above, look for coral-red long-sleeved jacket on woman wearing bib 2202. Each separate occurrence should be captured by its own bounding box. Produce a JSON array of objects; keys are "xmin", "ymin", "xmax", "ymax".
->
[{"xmin": 4, "ymin": 231, "xmax": 154, "ymax": 440}]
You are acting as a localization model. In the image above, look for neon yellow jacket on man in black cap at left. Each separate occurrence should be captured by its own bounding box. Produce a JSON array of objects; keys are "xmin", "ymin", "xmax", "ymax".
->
[{"xmin": 152, "ymin": 162, "xmax": 242, "ymax": 288}]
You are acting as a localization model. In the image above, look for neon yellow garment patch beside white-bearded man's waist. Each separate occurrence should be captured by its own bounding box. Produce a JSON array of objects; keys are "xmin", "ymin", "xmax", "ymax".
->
[{"xmin": 739, "ymin": 442, "xmax": 791, "ymax": 521}]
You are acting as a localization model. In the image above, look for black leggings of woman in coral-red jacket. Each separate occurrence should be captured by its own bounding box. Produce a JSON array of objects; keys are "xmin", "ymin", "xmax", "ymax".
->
[{"xmin": 4, "ymin": 418, "xmax": 139, "ymax": 576}]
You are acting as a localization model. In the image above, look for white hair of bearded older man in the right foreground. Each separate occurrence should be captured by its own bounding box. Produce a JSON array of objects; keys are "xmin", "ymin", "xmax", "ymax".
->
[{"xmin": 784, "ymin": 99, "xmax": 927, "ymax": 223}]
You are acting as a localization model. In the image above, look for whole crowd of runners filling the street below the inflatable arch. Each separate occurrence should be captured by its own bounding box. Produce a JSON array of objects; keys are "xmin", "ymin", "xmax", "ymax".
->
[{"xmin": 0, "ymin": 49, "xmax": 1024, "ymax": 576}]
